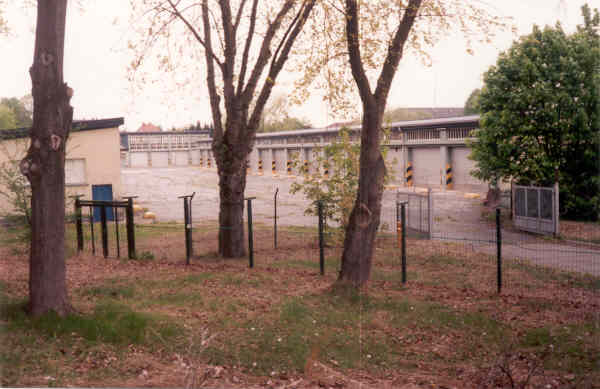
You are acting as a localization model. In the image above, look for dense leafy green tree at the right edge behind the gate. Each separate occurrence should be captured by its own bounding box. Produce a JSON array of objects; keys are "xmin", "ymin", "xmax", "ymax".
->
[{"xmin": 471, "ymin": 6, "xmax": 600, "ymax": 220}]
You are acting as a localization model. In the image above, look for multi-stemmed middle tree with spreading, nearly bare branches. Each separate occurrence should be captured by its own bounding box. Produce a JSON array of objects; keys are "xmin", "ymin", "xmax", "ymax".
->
[{"xmin": 132, "ymin": 0, "xmax": 316, "ymax": 257}]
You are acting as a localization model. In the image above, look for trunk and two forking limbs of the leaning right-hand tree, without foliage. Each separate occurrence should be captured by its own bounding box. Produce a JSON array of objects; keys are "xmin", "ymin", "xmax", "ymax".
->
[{"xmin": 338, "ymin": 0, "xmax": 422, "ymax": 287}]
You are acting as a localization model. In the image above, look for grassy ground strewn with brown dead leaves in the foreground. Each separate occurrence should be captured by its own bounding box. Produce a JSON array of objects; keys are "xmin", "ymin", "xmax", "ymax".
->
[{"xmin": 0, "ymin": 225, "xmax": 600, "ymax": 387}]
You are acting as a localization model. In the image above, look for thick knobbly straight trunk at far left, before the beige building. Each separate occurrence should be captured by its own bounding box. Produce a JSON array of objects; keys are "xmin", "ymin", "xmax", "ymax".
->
[{"xmin": 20, "ymin": 0, "xmax": 73, "ymax": 316}]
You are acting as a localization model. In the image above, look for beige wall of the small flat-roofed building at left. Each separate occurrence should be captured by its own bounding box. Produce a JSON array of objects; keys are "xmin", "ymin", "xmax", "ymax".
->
[{"xmin": 0, "ymin": 127, "xmax": 121, "ymax": 216}]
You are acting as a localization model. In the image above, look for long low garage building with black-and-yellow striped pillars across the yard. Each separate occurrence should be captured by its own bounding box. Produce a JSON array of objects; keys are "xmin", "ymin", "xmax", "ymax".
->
[{"xmin": 121, "ymin": 115, "xmax": 487, "ymax": 189}]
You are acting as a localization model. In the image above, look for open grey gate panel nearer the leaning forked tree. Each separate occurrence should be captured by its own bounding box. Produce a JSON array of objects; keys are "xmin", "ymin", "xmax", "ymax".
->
[{"xmin": 396, "ymin": 188, "xmax": 433, "ymax": 239}]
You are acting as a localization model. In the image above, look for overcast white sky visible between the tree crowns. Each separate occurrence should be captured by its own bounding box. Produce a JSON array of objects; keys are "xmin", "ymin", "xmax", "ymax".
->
[{"xmin": 0, "ymin": 0, "xmax": 600, "ymax": 131}]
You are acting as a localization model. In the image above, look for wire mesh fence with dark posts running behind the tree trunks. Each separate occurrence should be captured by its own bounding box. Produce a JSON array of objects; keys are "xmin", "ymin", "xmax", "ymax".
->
[{"xmin": 73, "ymin": 184, "xmax": 600, "ymax": 298}]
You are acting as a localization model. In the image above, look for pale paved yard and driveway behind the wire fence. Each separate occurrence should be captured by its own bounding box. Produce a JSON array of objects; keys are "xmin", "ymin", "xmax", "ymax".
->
[{"xmin": 121, "ymin": 167, "xmax": 600, "ymax": 276}]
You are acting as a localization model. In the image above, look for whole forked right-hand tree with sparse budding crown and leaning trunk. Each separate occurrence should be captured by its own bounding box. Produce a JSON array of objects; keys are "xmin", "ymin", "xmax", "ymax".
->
[{"xmin": 298, "ymin": 0, "xmax": 506, "ymax": 287}]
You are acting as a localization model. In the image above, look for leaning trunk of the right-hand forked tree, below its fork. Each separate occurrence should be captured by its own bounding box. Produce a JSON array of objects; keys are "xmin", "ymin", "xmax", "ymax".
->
[{"xmin": 339, "ymin": 107, "xmax": 386, "ymax": 287}]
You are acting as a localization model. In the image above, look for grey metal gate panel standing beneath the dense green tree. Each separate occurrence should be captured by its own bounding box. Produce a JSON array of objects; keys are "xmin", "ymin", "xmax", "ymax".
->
[{"xmin": 512, "ymin": 184, "xmax": 560, "ymax": 235}]
